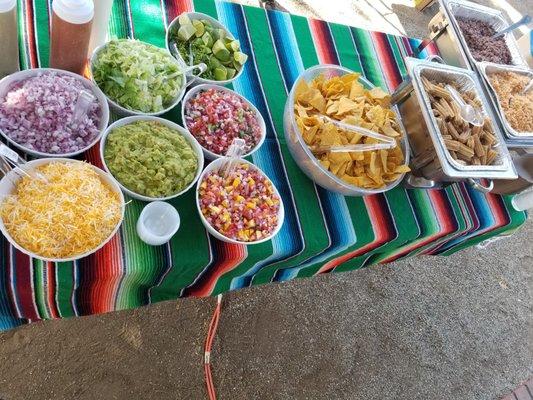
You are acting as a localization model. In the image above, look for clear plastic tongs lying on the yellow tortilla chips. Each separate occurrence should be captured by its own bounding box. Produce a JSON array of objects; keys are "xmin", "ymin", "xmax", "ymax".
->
[{"xmin": 310, "ymin": 115, "xmax": 396, "ymax": 154}]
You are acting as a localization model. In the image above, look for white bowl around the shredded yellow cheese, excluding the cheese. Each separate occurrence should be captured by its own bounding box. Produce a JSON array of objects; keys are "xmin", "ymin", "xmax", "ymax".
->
[{"xmin": 0, "ymin": 158, "xmax": 125, "ymax": 262}]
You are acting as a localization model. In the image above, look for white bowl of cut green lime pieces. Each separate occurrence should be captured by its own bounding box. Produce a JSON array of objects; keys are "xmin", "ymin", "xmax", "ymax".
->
[{"xmin": 166, "ymin": 12, "xmax": 248, "ymax": 85}]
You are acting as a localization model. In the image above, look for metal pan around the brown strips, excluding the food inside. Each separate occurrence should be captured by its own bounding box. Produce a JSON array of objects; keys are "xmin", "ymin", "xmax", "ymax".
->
[{"xmin": 393, "ymin": 58, "xmax": 517, "ymax": 182}]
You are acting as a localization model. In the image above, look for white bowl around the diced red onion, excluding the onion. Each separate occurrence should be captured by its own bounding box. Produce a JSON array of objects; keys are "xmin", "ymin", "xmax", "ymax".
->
[{"xmin": 0, "ymin": 68, "xmax": 109, "ymax": 157}]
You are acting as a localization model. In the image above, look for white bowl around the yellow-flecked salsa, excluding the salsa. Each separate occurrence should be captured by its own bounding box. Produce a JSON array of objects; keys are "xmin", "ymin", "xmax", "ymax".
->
[{"xmin": 196, "ymin": 158, "xmax": 285, "ymax": 246}]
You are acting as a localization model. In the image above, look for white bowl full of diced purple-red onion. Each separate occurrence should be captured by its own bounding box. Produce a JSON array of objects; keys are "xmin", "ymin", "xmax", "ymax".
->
[{"xmin": 0, "ymin": 68, "xmax": 109, "ymax": 157}]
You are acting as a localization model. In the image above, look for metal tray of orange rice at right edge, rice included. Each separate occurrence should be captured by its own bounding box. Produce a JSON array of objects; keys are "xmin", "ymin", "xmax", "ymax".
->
[{"xmin": 479, "ymin": 63, "xmax": 533, "ymax": 139}]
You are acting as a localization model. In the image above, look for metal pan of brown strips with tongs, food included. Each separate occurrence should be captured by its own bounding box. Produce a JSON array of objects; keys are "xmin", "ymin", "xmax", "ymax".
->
[{"xmin": 393, "ymin": 58, "xmax": 516, "ymax": 188}]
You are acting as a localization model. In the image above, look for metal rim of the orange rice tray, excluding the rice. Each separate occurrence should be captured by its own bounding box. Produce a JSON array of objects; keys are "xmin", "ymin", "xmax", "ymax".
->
[{"xmin": 478, "ymin": 62, "xmax": 533, "ymax": 138}]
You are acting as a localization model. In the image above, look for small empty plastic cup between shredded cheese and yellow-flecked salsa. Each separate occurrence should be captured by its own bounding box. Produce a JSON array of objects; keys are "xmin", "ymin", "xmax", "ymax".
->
[{"xmin": 137, "ymin": 201, "xmax": 180, "ymax": 246}]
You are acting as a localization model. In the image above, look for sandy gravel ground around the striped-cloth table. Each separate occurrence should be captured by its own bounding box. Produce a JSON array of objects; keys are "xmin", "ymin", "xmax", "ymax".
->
[{"xmin": 0, "ymin": 0, "xmax": 533, "ymax": 400}]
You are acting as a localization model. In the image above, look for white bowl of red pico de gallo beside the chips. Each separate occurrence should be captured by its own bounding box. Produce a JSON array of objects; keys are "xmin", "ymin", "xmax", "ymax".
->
[{"xmin": 181, "ymin": 84, "xmax": 266, "ymax": 160}]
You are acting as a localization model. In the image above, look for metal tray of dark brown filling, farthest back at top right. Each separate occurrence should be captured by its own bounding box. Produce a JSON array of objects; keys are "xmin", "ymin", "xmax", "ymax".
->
[{"xmin": 446, "ymin": 0, "xmax": 527, "ymax": 66}]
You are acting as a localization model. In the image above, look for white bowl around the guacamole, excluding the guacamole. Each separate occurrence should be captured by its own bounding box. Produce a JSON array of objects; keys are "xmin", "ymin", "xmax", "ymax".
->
[{"xmin": 100, "ymin": 115, "xmax": 204, "ymax": 201}]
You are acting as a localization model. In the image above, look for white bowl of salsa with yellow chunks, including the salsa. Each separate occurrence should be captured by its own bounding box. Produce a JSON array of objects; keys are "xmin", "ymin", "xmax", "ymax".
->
[{"xmin": 196, "ymin": 157, "xmax": 285, "ymax": 245}]
